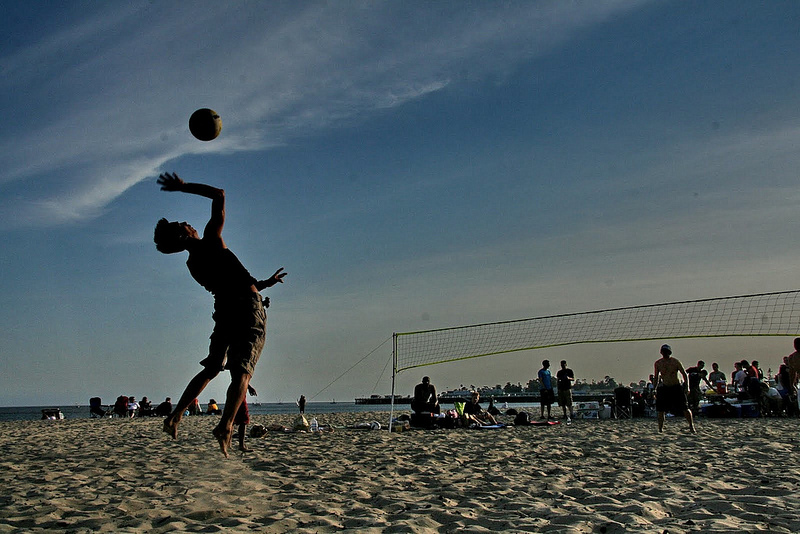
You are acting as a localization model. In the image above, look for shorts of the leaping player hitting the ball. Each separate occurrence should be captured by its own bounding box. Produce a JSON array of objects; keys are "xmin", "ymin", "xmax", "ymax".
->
[{"xmin": 200, "ymin": 293, "xmax": 267, "ymax": 375}]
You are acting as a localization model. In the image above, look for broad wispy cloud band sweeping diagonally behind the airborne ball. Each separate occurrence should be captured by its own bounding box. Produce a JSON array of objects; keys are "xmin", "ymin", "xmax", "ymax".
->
[{"xmin": 0, "ymin": 2, "xmax": 639, "ymax": 225}]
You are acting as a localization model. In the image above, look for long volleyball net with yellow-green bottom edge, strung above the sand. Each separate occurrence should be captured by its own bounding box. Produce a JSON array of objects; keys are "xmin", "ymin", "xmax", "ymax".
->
[{"xmin": 393, "ymin": 290, "xmax": 800, "ymax": 374}]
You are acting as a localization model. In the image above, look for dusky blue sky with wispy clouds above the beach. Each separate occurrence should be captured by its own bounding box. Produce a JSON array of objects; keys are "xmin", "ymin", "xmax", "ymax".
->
[{"xmin": 0, "ymin": 1, "xmax": 800, "ymax": 405}]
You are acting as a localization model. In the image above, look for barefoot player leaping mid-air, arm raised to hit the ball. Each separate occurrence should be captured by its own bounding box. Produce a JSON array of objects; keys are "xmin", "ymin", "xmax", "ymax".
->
[{"xmin": 153, "ymin": 173, "xmax": 286, "ymax": 457}]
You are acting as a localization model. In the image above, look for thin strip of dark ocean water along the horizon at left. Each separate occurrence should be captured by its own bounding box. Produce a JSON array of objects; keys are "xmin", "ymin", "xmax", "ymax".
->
[{"xmin": 0, "ymin": 402, "xmax": 394, "ymax": 421}]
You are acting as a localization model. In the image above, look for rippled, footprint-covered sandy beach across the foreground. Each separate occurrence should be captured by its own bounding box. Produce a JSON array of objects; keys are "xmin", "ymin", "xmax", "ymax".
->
[{"xmin": 0, "ymin": 412, "xmax": 800, "ymax": 533}]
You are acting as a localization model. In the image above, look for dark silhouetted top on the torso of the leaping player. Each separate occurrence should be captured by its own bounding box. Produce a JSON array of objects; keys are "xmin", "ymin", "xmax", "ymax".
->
[{"xmin": 186, "ymin": 243, "xmax": 256, "ymax": 299}]
